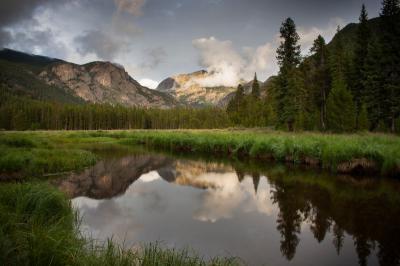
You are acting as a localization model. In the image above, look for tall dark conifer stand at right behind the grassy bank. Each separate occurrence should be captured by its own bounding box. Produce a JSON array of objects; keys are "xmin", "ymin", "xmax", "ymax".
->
[{"xmin": 227, "ymin": 0, "xmax": 400, "ymax": 132}]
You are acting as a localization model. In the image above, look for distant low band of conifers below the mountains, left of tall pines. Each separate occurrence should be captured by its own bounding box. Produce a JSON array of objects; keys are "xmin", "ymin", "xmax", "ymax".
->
[{"xmin": 0, "ymin": 88, "xmax": 232, "ymax": 130}]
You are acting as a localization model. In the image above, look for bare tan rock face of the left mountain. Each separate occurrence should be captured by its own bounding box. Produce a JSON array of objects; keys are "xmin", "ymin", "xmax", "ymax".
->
[{"xmin": 39, "ymin": 62, "xmax": 175, "ymax": 108}]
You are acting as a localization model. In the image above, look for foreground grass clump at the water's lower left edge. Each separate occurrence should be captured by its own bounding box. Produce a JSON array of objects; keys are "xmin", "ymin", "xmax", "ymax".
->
[{"xmin": 0, "ymin": 183, "xmax": 240, "ymax": 265}]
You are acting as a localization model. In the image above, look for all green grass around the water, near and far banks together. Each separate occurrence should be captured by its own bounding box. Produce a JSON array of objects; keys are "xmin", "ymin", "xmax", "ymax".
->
[{"xmin": 0, "ymin": 130, "xmax": 400, "ymax": 265}]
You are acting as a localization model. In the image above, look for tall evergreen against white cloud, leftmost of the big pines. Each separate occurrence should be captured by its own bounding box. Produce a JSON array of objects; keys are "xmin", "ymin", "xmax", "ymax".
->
[{"xmin": 276, "ymin": 18, "xmax": 301, "ymax": 131}]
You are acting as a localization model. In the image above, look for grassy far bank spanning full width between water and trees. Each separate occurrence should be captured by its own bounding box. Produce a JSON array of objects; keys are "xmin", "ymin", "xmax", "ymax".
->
[{"xmin": 0, "ymin": 130, "xmax": 400, "ymax": 179}]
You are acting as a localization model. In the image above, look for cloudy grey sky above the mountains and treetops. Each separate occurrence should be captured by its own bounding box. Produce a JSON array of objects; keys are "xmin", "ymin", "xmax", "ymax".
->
[{"xmin": 0, "ymin": 0, "xmax": 381, "ymax": 88}]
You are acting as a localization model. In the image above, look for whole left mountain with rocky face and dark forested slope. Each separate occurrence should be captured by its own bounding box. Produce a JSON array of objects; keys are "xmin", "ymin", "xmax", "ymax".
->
[{"xmin": 0, "ymin": 49, "xmax": 176, "ymax": 108}]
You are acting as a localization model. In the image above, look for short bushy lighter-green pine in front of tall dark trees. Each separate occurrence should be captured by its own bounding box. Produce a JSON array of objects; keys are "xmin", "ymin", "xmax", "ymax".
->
[{"xmin": 327, "ymin": 80, "xmax": 355, "ymax": 132}]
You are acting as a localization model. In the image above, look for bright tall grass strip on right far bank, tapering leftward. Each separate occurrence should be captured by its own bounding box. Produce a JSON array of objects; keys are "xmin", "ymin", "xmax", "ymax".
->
[{"xmin": 121, "ymin": 131, "xmax": 400, "ymax": 177}]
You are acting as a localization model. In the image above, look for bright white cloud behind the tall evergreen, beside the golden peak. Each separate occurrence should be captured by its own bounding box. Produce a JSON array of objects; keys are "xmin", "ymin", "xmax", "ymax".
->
[{"xmin": 192, "ymin": 18, "xmax": 345, "ymax": 87}]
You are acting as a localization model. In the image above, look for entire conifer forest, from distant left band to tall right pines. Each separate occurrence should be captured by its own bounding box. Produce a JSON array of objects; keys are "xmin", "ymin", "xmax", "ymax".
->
[{"xmin": 0, "ymin": 0, "xmax": 400, "ymax": 133}]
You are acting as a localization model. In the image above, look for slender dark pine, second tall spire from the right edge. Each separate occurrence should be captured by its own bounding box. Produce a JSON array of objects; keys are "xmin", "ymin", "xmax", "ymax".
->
[{"xmin": 349, "ymin": 5, "xmax": 370, "ymax": 129}]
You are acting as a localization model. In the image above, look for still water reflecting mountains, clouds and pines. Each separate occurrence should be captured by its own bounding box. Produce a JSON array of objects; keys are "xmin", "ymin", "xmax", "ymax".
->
[{"xmin": 56, "ymin": 149, "xmax": 400, "ymax": 265}]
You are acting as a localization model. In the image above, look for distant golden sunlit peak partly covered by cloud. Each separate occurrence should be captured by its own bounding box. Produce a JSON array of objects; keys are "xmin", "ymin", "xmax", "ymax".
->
[{"xmin": 156, "ymin": 70, "xmax": 236, "ymax": 106}]
